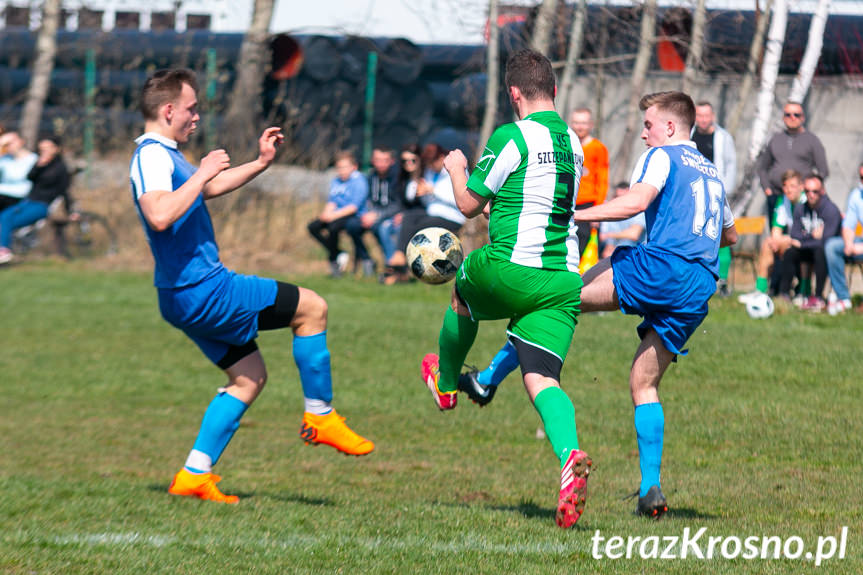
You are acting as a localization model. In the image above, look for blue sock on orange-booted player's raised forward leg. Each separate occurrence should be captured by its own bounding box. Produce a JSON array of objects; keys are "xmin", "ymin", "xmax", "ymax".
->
[{"xmin": 293, "ymin": 331, "xmax": 333, "ymax": 415}]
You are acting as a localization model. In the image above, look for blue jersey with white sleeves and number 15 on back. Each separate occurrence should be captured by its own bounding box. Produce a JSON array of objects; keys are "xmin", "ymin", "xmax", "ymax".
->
[{"xmin": 631, "ymin": 141, "xmax": 734, "ymax": 277}]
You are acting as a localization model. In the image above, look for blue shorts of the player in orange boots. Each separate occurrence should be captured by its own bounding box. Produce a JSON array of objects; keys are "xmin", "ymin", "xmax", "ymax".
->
[{"xmin": 159, "ymin": 270, "xmax": 278, "ymax": 365}]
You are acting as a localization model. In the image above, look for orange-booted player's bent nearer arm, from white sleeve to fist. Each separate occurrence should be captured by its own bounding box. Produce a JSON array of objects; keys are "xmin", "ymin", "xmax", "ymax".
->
[{"xmin": 138, "ymin": 150, "xmax": 231, "ymax": 232}]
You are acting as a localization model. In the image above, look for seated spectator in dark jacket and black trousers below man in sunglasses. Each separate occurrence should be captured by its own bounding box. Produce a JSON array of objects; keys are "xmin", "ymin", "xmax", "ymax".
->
[{"xmin": 779, "ymin": 174, "xmax": 842, "ymax": 312}]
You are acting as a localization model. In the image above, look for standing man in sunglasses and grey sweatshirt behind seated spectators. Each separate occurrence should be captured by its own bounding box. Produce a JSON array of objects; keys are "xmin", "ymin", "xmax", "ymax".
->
[{"xmin": 758, "ymin": 102, "xmax": 829, "ymax": 218}]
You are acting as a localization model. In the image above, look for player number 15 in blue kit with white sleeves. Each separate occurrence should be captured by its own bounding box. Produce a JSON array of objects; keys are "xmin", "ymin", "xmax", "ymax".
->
[{"xmin": 459, "ymin": 92, "xmax": 737, "ymax": 518}]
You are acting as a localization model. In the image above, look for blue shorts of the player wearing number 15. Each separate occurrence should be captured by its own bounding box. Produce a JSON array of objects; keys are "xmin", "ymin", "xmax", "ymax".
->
[{"xmin": 611, "ymin": 244, "xmax": 716, "ymax": 355}]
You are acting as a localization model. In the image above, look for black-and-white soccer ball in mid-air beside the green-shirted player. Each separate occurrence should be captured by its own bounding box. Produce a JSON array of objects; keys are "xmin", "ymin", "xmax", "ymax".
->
[{"xmin": 405, "ymin": 228, "xmax": 464, "ymax": 284}]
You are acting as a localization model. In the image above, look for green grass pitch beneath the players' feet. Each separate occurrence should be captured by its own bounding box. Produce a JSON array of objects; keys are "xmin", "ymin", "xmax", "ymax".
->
[{"xmin": 0, "ymin": 263, "xmax": 863, "ymax": 574}]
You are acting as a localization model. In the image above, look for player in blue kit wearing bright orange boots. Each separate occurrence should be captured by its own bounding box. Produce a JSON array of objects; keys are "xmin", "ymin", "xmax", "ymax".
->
[{"xmin": 129, "ymin": 69, "xmax": 374, "ymax": 503}]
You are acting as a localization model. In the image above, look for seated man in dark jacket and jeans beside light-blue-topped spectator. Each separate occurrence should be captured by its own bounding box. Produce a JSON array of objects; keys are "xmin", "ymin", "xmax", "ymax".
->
[{"xmin": 347, "ymin": 146, "xmax": 402, "ymax": 276}]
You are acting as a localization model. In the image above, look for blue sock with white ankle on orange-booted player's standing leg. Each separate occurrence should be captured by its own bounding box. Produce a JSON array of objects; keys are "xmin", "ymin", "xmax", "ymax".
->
[{"xmin": 185, "ymin": 391, "xmax": 249, "ymax": 473}]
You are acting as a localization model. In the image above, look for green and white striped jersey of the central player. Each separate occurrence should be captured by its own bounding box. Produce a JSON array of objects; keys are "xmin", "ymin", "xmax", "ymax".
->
[{"xmin": 467, "ymin": 111, "xmax": 584, "ymax": 272}]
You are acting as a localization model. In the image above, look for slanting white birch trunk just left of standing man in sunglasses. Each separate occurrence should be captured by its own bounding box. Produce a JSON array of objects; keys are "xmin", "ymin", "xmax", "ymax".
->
[{"xmin": 732, "ymin": 0, "xmax": 788, "ymax": 214}]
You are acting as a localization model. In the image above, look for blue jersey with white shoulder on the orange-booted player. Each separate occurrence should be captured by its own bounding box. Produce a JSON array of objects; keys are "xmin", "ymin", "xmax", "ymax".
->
[{"xmin": 129, "ymin": 133, "xmax": 225, "ymax": 288}]
